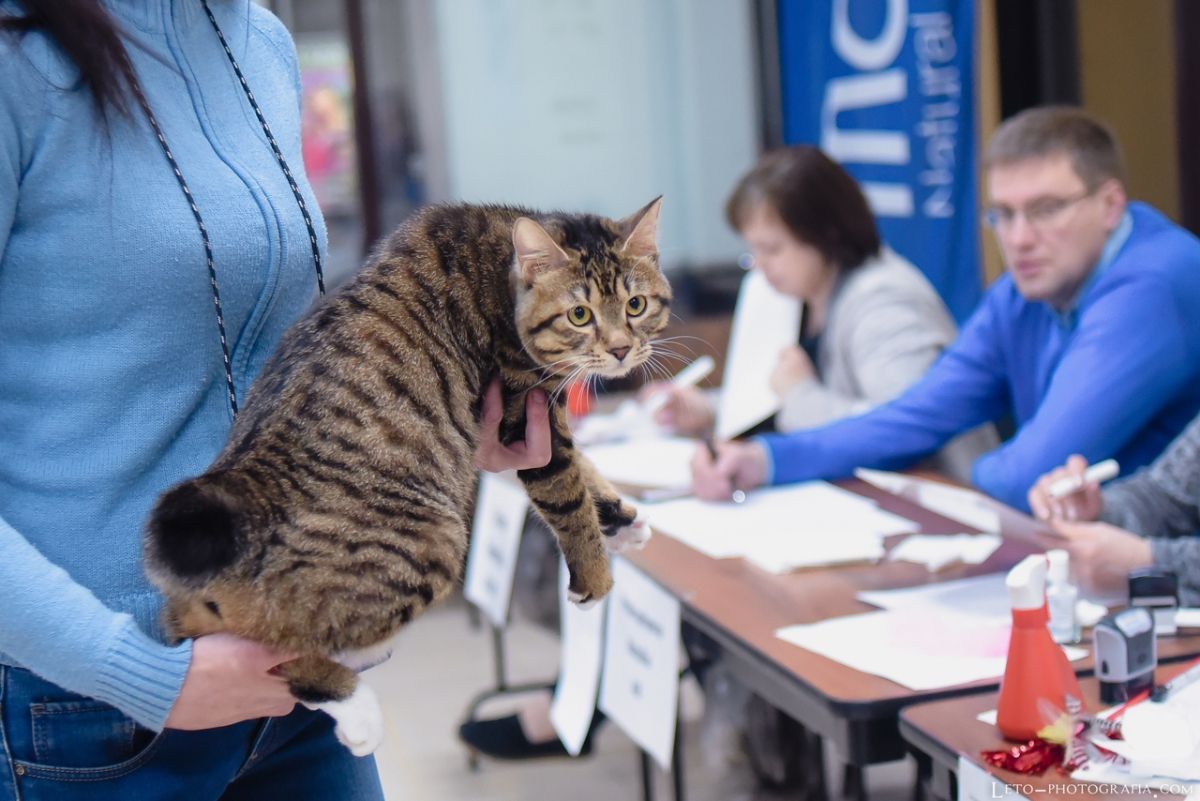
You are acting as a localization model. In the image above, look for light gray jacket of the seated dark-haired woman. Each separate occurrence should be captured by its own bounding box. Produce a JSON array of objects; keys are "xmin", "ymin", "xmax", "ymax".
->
[{"xmin": 775, "ymin": 247, "xmax": 1000, "ymax": 482}]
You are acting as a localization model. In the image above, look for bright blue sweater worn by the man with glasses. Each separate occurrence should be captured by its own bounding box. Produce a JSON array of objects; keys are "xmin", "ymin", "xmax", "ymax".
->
[{"xmin": 762, "ymin": 203, "xmax": 1200, "ymax": 508}]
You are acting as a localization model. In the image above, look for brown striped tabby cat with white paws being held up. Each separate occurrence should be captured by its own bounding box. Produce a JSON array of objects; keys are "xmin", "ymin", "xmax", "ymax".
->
[{"xmin": 145, "ymin": 199, "xmax": 671, "ymax": 754}]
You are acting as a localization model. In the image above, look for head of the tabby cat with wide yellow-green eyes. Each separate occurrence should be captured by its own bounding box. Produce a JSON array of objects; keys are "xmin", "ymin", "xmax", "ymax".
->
[{"xmin": 512, "ymin": 195, "xmax": 671, "ymax": 378}]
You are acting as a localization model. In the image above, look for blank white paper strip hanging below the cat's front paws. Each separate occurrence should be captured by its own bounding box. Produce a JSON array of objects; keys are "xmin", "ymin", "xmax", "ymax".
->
[{"xmin": 550, "ymin": 559, "xmax": 608, "ymax": 757}]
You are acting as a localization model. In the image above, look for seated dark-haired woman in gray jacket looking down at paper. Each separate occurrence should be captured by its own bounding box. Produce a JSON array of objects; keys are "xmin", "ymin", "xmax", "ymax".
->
[{"xmin": 648, "ymin": 145, "xmax": 996, "ymax": 481}]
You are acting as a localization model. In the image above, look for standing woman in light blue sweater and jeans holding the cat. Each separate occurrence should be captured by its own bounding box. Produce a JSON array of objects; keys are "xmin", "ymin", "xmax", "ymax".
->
[{"xmin": 0, "ymin": 0, "xmax": 548, "ymax": 801}]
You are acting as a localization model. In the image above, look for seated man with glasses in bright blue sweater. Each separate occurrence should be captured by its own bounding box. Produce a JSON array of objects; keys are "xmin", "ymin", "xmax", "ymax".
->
[{"xmin": 692, "ymin": 107, "xmax": 1200, "ymax": 508}]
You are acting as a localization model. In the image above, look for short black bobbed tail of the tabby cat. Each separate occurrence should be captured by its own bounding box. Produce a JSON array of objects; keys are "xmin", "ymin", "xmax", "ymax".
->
[{"xmin": 145, "ymin": 472, "xmax": 246, "ymax": 585}]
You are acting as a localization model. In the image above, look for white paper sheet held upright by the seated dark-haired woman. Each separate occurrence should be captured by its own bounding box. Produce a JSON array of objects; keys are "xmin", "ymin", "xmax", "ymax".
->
[{"xmin": 715, "ymin": 271, "xmax": 800, "ymax": 439}]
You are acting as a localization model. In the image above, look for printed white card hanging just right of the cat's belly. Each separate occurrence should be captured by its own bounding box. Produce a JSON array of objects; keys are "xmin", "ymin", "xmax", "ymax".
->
[{"xmin": 462, "ymin": 472, "xmax": 529, "ymax": 628}]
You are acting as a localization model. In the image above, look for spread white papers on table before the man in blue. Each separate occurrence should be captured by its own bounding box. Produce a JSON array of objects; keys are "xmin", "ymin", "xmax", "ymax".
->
[{"xmin": 642, "ymin": 481, "xmax": 917, "ymax": 573}]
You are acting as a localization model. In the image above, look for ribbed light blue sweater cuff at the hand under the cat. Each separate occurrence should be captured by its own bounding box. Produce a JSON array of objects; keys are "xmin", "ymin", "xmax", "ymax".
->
[{"xmin": 92, "ymin": 618, "xmax": 192, "ymax": 731}]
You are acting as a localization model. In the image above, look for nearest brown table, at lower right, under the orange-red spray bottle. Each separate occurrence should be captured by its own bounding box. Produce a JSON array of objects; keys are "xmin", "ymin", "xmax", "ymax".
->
[{"xmin": 900, "ymin": 661, "xmax": 1183, "ymax": 801}]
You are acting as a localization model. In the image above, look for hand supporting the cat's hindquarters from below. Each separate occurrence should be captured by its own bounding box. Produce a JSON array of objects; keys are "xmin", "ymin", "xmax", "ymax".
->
[{"xmin": 166, "ymin": 632, "xmax": 296, "ymax": 729}]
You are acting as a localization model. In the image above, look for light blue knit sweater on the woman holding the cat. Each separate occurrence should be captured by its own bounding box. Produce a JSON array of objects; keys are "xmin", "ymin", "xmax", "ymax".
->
[{"xmin": 0, "ymin": 0, "xmax": 324, "ymax": 729}]
